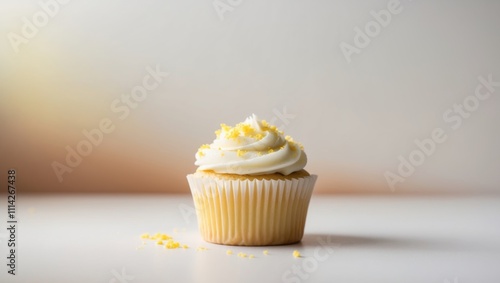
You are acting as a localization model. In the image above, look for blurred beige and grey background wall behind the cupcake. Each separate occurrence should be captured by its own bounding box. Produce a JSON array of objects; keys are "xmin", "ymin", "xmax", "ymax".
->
[{"xmin": 0, "ymin": 0, "xmax": 500, "ymax": 193}]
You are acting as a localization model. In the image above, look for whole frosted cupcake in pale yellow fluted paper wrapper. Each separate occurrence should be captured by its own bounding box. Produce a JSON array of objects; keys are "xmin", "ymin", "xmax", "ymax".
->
[{"xmin": 187, "ymin": 115, "xmax": 317, "ymax": 246}]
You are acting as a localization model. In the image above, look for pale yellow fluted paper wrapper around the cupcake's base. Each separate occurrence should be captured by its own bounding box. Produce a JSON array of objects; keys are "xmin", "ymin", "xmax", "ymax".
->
[{"xmin": 187, "ymin": 174, "xmax": 317, "ymax": 246}]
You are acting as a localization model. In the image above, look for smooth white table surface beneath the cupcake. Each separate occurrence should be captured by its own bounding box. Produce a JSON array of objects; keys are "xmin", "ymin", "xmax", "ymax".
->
[{"xmin": 0, "ymin": 194, "xmax": 500, "ymax": 283}]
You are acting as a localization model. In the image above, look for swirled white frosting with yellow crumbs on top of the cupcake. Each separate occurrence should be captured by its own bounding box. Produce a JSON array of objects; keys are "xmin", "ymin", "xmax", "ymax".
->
[{"xmin": 195, "ymin": 114, "xmax": 307, "ymax": 175}]
